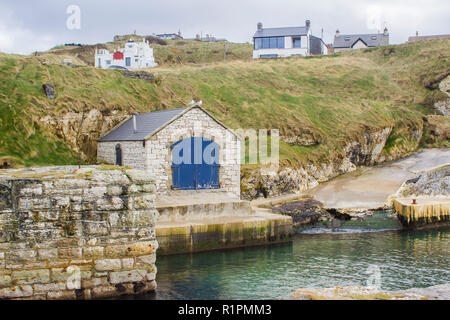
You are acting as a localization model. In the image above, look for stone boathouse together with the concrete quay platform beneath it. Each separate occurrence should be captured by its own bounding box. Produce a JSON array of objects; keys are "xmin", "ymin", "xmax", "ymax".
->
[{"xmin": 97, "ymin": 104, "xmax": 292, "ymax": 254}]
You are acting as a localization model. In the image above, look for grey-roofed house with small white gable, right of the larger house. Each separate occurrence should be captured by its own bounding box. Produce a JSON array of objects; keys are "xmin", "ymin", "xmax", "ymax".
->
[{"xmin": 333, "ymin": 28, "xmax": 389, "ymax": 52}]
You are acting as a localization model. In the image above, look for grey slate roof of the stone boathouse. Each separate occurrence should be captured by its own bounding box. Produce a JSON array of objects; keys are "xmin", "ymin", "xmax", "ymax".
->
[{"xmin": 98, "ymin": 108, "xmax": 188, "ymax": 142}]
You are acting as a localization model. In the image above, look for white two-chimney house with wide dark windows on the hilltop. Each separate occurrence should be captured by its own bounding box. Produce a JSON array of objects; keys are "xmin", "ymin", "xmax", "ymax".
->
[{"xmin": 253, "ymin": 20, "xmax": 328, "ymax": 59}]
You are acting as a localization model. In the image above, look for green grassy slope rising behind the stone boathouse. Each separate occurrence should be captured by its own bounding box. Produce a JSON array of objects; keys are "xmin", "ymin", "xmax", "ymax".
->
[{"xmin": 0, "ymin": 39, "xmax": 450, "ymax": 166}]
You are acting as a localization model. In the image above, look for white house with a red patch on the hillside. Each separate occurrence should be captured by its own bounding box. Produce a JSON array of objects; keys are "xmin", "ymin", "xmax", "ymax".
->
[{"xmin": 95, "ymin": 39, "xmax": 158, "ymax": 70}]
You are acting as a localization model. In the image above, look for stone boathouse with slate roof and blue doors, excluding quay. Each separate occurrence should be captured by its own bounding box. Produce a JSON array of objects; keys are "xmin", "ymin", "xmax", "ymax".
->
[{"xmin": 97, "ymin": 104, "xmax": 241, "ymax": 197}]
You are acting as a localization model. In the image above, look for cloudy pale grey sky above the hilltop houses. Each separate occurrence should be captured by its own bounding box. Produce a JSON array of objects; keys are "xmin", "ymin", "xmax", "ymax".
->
[{"xmin": 0, "ymin": 0, "xmax": 450, "ymax": 54}]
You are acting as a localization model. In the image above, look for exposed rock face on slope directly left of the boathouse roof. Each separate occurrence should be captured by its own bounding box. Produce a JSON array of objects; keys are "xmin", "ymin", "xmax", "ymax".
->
[{"xmin": 40, "ymin": 109, "xmax": 127, "ymax": 162}]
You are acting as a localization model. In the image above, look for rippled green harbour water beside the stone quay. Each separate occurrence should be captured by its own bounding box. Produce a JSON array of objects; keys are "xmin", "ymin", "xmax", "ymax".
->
[{"xmin": 146, "ymin": 222, "xmax": 450, "ymax": 299}]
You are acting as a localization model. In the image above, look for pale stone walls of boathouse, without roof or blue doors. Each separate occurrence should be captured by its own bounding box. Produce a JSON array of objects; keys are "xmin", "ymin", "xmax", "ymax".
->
[{"xmin": 97, "ymin": 108, "xmax": 241, "ymax": 197}]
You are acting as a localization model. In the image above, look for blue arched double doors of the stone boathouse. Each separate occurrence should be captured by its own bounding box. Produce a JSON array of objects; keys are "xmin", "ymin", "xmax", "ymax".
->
[{"xmin": 171, "ymin": 138, "xmax": 220, "ymax": 190}]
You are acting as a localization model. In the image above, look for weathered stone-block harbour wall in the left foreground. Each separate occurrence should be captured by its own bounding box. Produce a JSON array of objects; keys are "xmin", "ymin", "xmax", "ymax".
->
[{"xmin": 0, "ymin": 166, "xmax": 158, "ymax": 299}]
